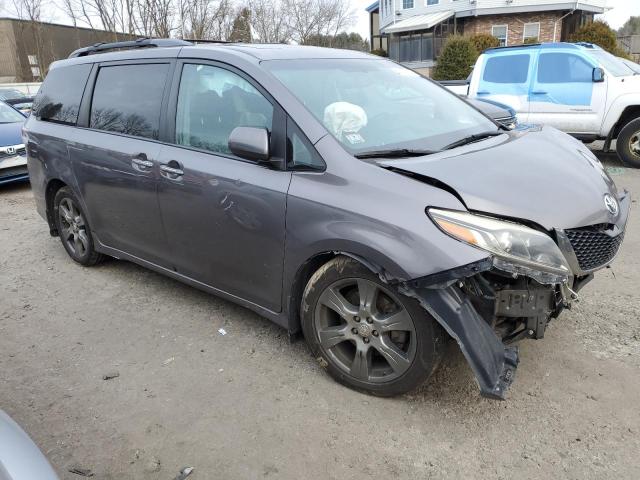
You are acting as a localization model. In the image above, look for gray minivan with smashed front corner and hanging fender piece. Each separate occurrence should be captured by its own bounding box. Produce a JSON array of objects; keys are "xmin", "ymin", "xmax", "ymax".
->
[{"xmin": 24, "ymin": 40, "xmax": 630, "ymax": 398}]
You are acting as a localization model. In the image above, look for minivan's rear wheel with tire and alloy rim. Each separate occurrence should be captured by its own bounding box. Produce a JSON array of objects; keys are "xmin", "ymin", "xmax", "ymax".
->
[{"xmin": 53, "ymin": 187, "xmax": 104, "ymax": 267}]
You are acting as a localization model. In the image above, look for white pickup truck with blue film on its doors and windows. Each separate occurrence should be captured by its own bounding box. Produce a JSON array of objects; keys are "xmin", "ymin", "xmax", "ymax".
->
[{"xmin": 447, "ymin": 43, "xmax": 640, "ymax": 168}]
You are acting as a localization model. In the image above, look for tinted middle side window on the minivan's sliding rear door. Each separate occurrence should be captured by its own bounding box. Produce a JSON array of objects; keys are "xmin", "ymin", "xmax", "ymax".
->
[{"xmin": 89, "ymin": 63, "xmax": 169, "ymax": 140}]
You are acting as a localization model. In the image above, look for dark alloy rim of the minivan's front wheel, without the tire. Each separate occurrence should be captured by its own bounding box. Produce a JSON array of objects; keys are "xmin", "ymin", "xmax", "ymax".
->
[{"xmin": 314, "ymin": 278, "xmax": 417, "ymax": 383}]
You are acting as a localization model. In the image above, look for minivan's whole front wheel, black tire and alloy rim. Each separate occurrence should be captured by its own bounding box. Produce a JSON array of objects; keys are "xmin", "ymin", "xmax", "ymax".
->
[{"xmin": 301, "ymin": 256, "xmax": 445, "ymax": 397}]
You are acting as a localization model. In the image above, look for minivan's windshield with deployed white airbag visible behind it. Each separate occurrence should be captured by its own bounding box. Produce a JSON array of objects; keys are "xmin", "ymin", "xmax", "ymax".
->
[{"xmin": 263, "ymin": 59, "xmax": 498, "ymax": 154}]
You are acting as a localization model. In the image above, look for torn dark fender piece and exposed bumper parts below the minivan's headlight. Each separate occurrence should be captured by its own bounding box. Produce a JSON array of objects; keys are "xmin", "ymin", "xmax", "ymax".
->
[{"xmin": 402, "ymin": 257, "xmax": 592, "ymax": 400}]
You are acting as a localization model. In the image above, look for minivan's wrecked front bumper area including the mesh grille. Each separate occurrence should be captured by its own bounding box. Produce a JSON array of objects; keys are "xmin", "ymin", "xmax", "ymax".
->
[{"xmin": 401, "ymin": 191, "xmax": 631, "ymax": 399}]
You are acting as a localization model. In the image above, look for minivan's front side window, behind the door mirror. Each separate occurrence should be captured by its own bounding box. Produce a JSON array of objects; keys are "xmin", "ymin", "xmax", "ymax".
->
[{"xmin": 176, "ymin": 64, "xmax": 273, "ymax": 154}]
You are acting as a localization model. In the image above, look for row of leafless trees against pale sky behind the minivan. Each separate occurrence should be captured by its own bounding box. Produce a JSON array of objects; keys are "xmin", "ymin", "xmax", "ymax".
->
[{"xmin": 52, "ymin": 0, "xmax": 354, "ymax": 44}]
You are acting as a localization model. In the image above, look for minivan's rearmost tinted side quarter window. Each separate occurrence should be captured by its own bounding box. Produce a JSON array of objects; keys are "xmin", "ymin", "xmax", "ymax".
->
[{"xmin": 33, "ymin": 64, "xmax": 91, "ymax": 125}]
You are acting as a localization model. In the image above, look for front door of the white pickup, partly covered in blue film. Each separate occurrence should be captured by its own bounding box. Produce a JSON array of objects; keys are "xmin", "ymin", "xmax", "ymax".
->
[{"xmin": 529, "ymin": 50, "xmax": 607, "ymax": 134}]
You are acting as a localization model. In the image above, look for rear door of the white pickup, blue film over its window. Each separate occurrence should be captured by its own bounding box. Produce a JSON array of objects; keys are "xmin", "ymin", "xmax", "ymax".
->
[{"xmin": 469, "ymin": 49, "xmax": 535, "ymax": 122}]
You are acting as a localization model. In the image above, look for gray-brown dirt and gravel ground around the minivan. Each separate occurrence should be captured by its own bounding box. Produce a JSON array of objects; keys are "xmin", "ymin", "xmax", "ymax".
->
[{"xmin": 0, "ymin": 152, "xmax": 640, "ymax": 480}]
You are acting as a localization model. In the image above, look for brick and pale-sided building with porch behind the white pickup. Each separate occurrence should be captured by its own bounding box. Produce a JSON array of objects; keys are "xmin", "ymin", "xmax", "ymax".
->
[{"xmin": 367, "ymin": 0, "xmax": 607, "ymax": 74}]
